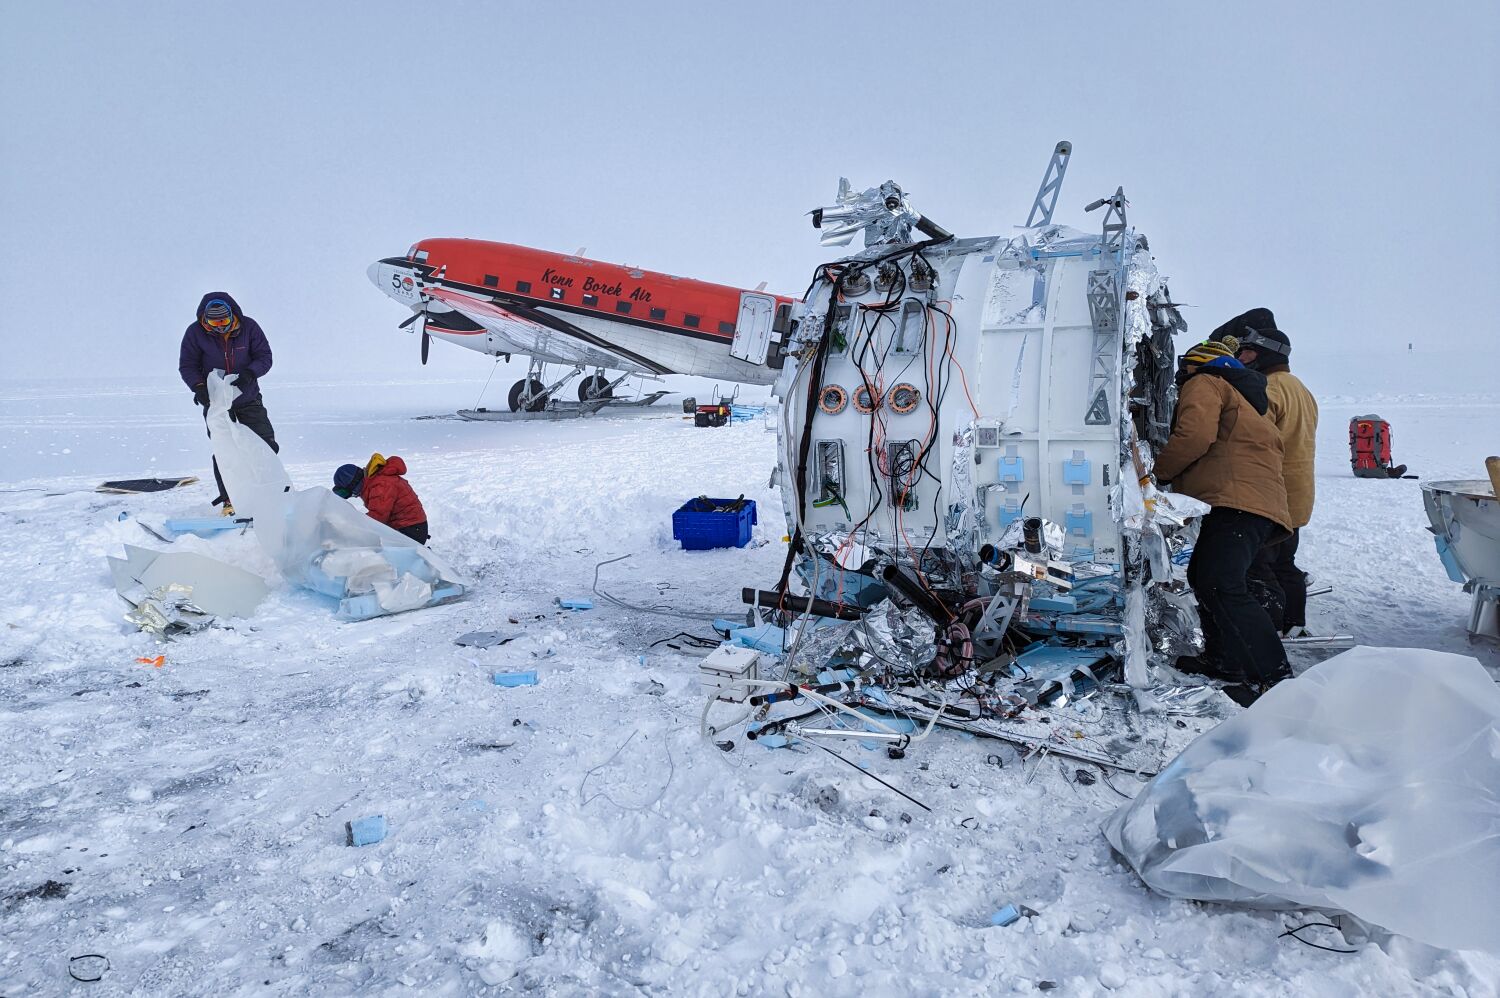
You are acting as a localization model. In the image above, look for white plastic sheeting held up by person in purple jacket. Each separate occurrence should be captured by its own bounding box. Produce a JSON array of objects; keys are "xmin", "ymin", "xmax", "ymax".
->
[{"xmin": 209, "ymin": 372, "xmax": 465, "ymax": 620}]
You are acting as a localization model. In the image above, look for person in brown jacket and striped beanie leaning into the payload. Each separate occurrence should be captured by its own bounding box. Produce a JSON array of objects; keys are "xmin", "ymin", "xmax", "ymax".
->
[{"xmin": 1155, "ymin": 341, "xmax": 1292, "ymax": 705}]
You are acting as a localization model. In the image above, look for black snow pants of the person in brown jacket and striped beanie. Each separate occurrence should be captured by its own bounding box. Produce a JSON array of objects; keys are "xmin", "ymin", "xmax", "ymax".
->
[{"xmin": 1188, "ymin": 506, "xmax": 1292, "ymax": 684}]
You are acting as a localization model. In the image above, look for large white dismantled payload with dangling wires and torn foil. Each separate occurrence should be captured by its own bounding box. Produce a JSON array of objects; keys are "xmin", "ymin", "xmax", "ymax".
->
[{"xmin": 744, "ymin": 143, "xmax": 1208, "ymax": 729}]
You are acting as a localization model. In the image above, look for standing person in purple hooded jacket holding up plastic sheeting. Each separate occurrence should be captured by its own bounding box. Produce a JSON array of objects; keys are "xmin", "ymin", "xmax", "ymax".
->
[{"xmin": 177, "ymin": 291, "xmax": 281, "ymax": 516}]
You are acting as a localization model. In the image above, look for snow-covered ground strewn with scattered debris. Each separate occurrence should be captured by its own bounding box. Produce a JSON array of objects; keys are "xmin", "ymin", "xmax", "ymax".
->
[{"xmin": 0, "ymin": 378, "xmax": 1500, "ymax": 996}]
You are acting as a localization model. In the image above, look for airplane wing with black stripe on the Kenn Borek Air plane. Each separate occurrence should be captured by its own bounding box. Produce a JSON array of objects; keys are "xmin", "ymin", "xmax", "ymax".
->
[{"xmin": 423, "ymin": 285, "xmax": 672, "ymax": 374}]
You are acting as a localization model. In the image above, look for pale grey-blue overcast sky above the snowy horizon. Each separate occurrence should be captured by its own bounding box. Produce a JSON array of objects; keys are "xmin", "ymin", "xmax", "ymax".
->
[{"xmin": 0, "ymin": 0, "xmax": 1500, "ymax": 393}]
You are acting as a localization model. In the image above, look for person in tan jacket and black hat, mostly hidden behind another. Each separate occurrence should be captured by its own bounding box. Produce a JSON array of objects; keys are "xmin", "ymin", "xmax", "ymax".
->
[{"xmin": 1221, "ymin": 309, "xmax": 1317, "ymax": 636}]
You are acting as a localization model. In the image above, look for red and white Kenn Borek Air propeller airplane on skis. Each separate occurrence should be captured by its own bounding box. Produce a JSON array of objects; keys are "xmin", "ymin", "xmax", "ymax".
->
[{"xmin": 368, "ymin": 239, "xmax": 794, "ymax": 411}]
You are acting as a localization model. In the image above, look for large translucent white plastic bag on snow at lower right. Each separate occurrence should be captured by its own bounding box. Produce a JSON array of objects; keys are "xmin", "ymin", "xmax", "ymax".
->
[{"xmin": 1104, "ymin": 648, "xmax": 1500, "ymax": 951}]
